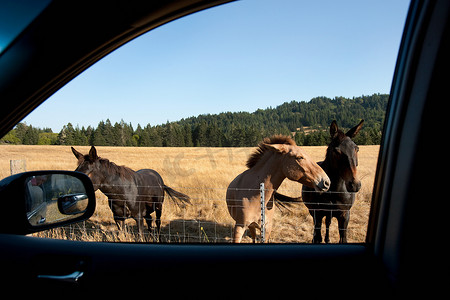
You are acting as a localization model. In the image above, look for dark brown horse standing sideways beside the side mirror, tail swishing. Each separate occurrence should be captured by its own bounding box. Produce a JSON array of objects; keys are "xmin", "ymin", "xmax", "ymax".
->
[{"xmin": 72, "ymin": 146, "xmax": 190, "ymax": 239}]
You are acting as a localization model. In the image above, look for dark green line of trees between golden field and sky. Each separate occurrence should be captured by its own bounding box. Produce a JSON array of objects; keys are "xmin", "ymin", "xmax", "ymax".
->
[{"xmin": 0, "ymin": 94, "xmax": 389, "ymax": 147}]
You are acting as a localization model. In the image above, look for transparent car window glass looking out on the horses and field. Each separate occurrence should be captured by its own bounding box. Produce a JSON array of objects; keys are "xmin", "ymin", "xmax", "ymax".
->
[{"xmin": 0, "ymin": 1, "xmax": 408, "ymax": 243}]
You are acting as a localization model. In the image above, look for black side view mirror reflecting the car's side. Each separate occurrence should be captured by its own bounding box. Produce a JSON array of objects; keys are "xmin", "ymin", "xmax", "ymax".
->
[{"xmin": 0, "ymin": 171, "xmax": 95, "ymax": 234}]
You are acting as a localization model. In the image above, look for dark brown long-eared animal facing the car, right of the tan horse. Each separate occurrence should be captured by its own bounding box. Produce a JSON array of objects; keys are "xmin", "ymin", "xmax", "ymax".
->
[{"xmin": 275, "ymin": 120, "xmax": 364, "ymax": 243}]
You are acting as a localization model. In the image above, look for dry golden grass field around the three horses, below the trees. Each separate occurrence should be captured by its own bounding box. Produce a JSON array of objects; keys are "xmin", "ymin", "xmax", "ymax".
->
[{"xmin": 0, "ymin": 145, "xmax": 379, "ymax": 243}]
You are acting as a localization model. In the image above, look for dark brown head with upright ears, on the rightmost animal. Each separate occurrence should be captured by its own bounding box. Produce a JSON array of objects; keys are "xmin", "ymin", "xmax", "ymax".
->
[{"xmin": 326, "ymin": 120, "xmax": 364, "ymax": 192}]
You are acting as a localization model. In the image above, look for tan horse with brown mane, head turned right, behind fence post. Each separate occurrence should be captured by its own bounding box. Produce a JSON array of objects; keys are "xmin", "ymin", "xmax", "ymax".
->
[{"xmin": 226, "ymin": 135, "xmax": 330, "ymax": 243}]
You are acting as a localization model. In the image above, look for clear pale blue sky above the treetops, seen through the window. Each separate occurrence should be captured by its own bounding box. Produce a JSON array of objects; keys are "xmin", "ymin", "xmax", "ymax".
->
[{"xmin": 24, "ymin": 0, "xmax": 409, "ymax": 132}]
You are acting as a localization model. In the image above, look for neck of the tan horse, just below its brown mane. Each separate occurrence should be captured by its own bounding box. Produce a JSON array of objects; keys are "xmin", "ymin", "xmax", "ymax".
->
[{"xmin": 252, "ymin": 152, "xmax": 286, "ymax": 190}]
